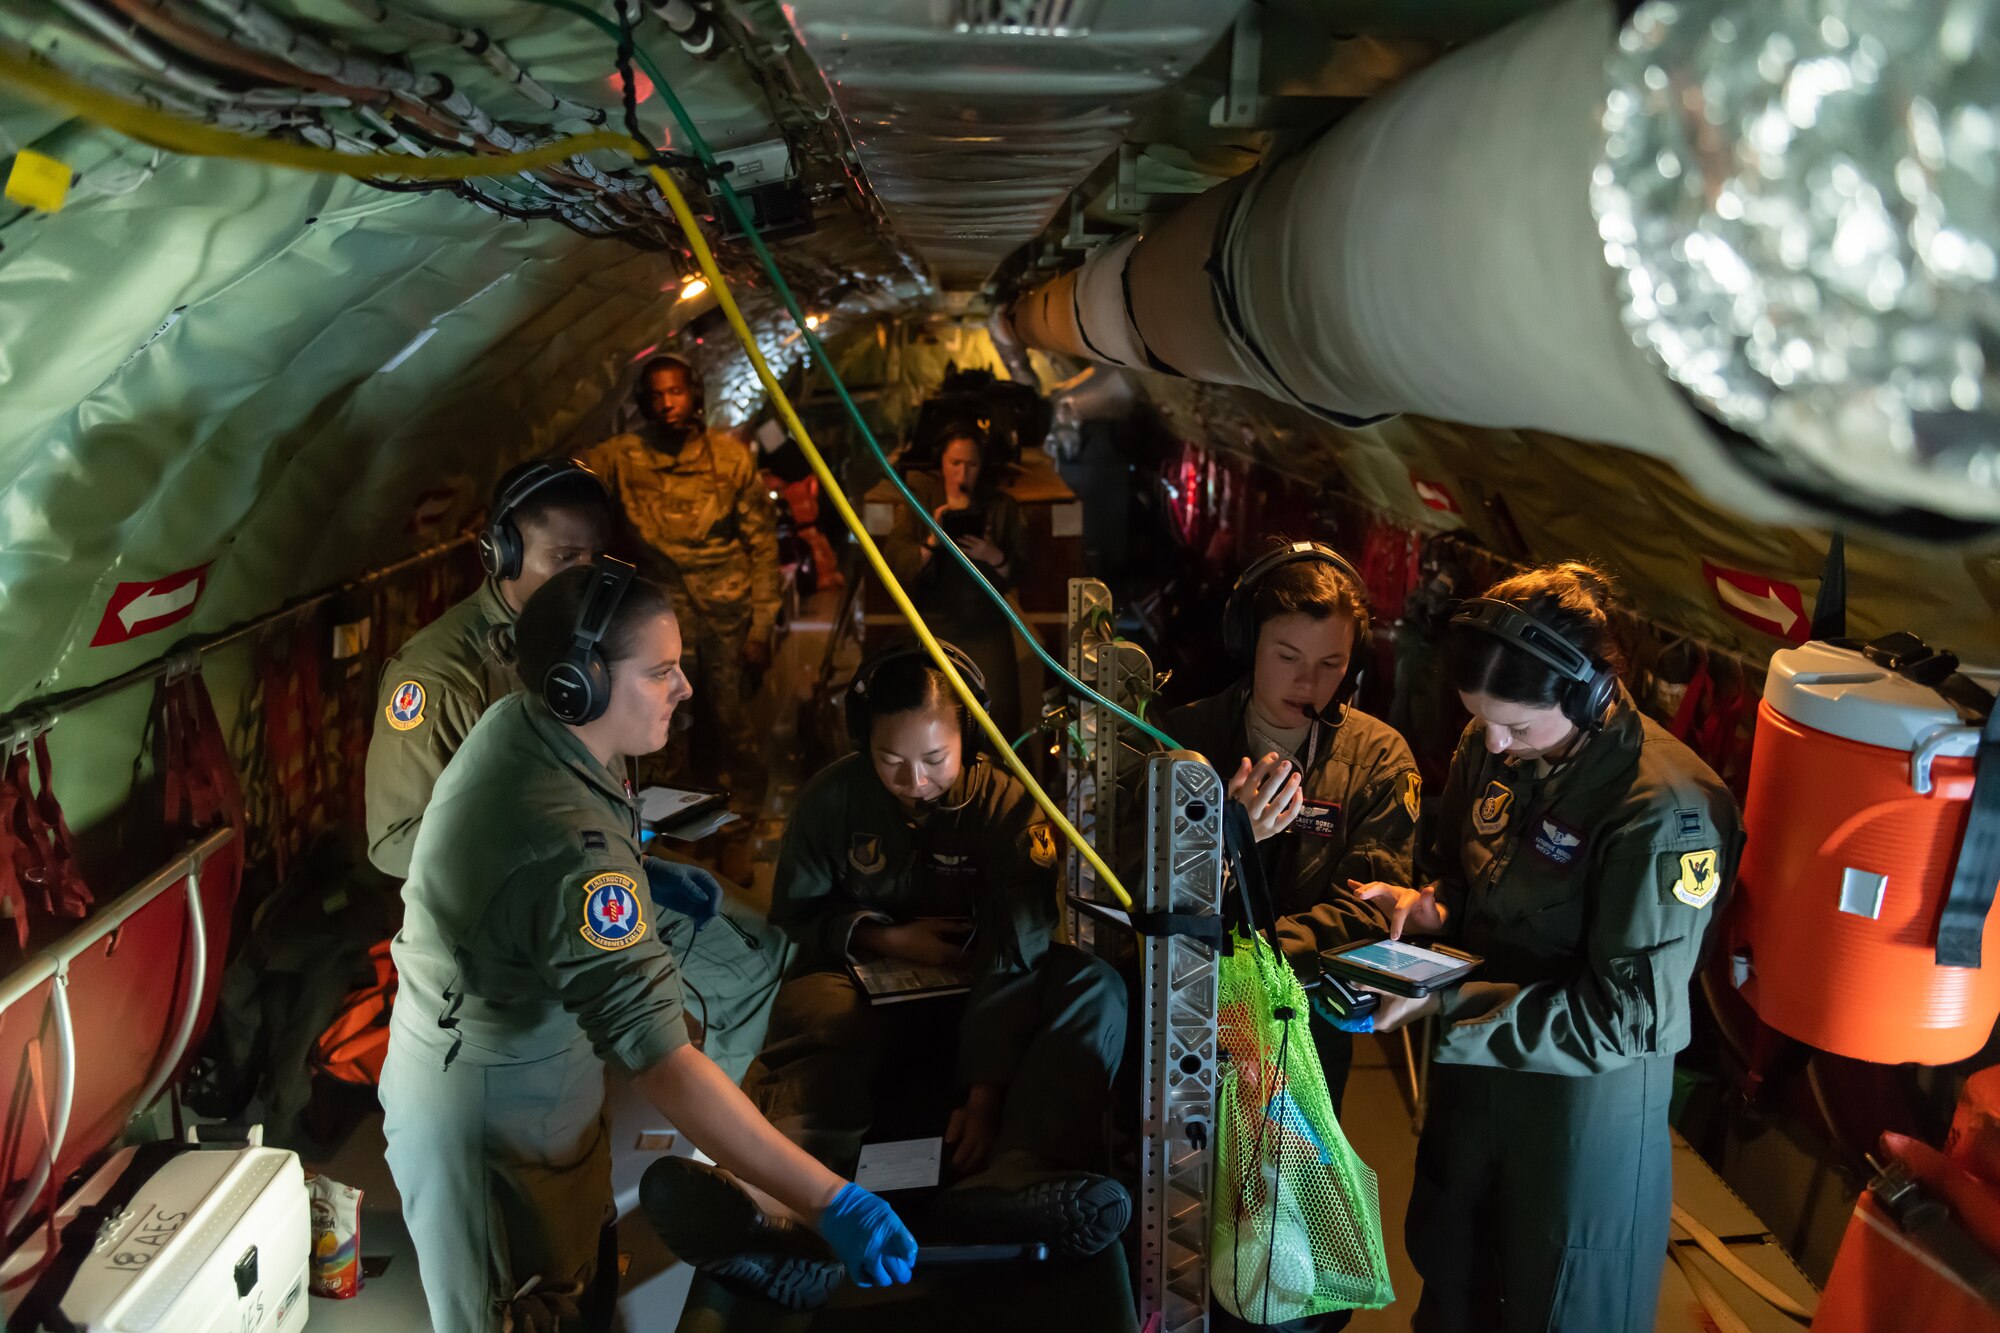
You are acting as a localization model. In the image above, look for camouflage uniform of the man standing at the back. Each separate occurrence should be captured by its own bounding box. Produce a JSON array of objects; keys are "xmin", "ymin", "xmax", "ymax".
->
[{"xmin": 586, "ymin": 428, "xmax": 782, "ymax": 809}]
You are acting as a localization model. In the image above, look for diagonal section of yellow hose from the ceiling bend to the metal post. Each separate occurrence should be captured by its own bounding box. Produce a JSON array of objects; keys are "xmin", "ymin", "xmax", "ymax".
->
[{"xmin": 644, "ymin": 156, "xmax": 1132, "ymax": 909}]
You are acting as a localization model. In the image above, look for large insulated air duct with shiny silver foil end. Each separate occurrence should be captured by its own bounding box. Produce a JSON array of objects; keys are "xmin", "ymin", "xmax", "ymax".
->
[{"xmin": 1008, "ymin": 0, "xmax": 2000, "ymax": 538}]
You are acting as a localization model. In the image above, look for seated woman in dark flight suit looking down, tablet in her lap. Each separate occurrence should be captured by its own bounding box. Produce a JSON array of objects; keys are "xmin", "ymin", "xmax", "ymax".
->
[{"xmin": 642, "ymin": 644, "xmax": 1132, "ymax": 1304}]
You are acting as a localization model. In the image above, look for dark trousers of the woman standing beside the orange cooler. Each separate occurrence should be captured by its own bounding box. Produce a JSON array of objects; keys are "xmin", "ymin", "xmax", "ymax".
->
[{"xmin": 1404, "ymin": 1057, "xmax": 1674, "ymax": 1333}]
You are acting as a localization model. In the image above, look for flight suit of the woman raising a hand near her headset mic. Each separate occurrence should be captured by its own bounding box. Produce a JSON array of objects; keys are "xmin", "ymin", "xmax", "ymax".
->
[{"xmin": 1160, "ymin": 681, "xmax": 1424, "ymax": 1115}]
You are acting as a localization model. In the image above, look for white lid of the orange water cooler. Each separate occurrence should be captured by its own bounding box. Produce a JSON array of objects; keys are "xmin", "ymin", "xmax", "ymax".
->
[{"xmin": 1764, "ymin": 642, "xmax": 1980, "ymax": 755}]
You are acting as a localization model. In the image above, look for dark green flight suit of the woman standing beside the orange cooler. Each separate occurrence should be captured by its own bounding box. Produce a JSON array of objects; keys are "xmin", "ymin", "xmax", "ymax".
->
[{"xmin": 1406, "ymin": 691, "xmax": 1742, "ymax": 1333}]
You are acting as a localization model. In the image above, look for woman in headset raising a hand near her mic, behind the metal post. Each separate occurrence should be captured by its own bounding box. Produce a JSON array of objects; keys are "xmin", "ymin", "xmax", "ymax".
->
[{"xmin": 1160, "ymin": 542, "xmax": 1422, "ymax": 1113}]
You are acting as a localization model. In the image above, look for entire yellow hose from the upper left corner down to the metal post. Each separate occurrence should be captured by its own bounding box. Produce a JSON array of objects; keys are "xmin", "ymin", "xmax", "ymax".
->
[{"xmin": 0, "ymin": 46, "xmax": 1132, "ymax": 909}]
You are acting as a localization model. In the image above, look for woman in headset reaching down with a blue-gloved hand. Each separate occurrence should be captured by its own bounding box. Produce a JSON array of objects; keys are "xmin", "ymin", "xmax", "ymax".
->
[{"xmin": 382, "ymin": 560, "xmax": 916, "ymax": 1333}]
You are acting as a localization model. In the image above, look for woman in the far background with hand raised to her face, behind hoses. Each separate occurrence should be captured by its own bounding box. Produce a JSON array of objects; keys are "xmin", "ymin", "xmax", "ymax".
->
[{"xmin": 882, "ymin": 422, "xmax": 1026, "ymax": 737}]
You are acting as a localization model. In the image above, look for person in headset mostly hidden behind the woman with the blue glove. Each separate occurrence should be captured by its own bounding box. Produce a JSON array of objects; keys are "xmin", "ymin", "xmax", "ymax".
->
[{"xmin": 364, "ymin": 458, "xmax": 790, "ymax": 1081}]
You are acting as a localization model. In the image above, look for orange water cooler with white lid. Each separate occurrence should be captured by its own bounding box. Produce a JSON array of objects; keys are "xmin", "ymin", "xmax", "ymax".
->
[{"xmin": 1730, "ymin": 642, "xmax": 2000, "ymax": 1065}]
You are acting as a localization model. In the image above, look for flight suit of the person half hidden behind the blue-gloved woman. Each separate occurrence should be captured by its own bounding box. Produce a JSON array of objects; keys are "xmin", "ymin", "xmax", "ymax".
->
[{"xmin": 366, "ymin": 578, "xmax": 790, "ymax": 1081}]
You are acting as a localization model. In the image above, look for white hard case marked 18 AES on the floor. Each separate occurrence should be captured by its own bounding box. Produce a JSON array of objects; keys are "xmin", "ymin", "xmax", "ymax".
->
[{"xmin": 23, "ymin": 1135, "xmax": 312, "ymax": 1333}]
